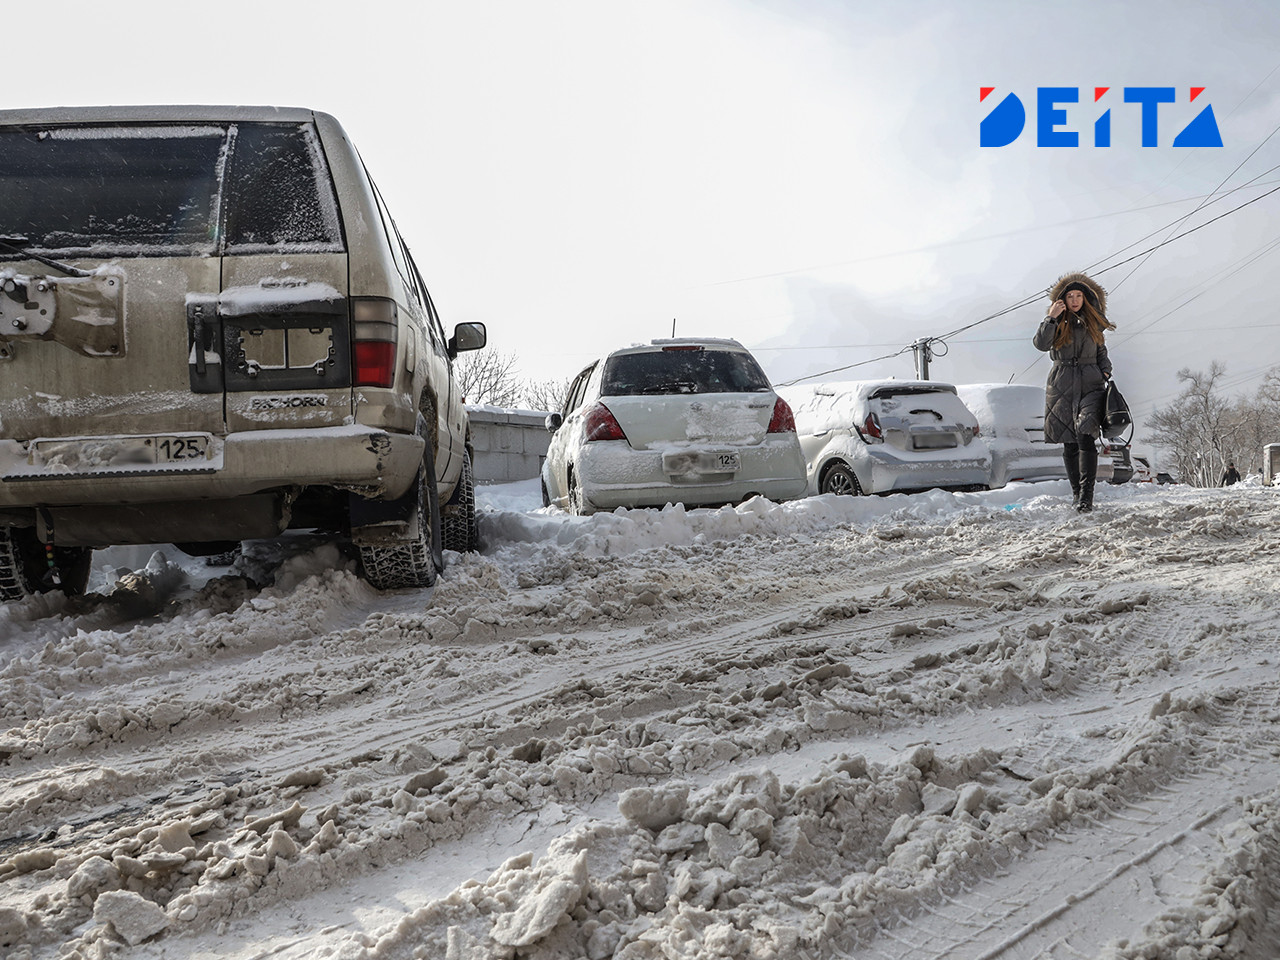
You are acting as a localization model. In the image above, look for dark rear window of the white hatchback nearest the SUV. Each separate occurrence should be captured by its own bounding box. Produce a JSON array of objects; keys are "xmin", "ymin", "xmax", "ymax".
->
[{"xmin": 600, "ymin": 349, "xmax": 772, "ymax": 397}]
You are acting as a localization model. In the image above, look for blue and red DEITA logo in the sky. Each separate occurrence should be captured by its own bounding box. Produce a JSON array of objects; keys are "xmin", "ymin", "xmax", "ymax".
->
[{"xmin": 979, "ymin": 87, "xmax": 1222, "ymax": 147}]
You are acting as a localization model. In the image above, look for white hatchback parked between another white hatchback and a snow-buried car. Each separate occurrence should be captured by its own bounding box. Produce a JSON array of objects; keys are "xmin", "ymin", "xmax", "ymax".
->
[{"xmin": 782, "ymin": 380, "xmax": 991, "ymax": 494}]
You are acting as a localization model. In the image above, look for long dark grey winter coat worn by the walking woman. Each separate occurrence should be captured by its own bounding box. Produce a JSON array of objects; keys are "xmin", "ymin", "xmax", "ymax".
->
[{"xmin": 1033, "ymin": 312, "xmax": 1111, "ymax": 443}]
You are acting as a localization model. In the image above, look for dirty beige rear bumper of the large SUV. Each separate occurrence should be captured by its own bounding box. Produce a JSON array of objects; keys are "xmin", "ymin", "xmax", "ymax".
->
[{"xmin": 0, "ymin": 425, "xmax": 422, "ymax": 509}]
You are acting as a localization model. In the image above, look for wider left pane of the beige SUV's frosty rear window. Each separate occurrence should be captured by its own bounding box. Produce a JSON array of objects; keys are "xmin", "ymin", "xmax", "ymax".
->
[{"xmin": 0, "ymin": 127, "xmax": 225, "ymax": 255}]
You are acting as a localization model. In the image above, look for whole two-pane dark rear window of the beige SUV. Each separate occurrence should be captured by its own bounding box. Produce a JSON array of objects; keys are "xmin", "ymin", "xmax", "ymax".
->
[{"xmin": 0, "ymin": 123, "xmax": 342, "ymax": 256}]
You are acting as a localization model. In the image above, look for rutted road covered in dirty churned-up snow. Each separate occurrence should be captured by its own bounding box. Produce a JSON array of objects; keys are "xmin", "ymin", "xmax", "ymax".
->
[{"xmin": 0, "ymin": 481, "xmax": 1280, "ymax": 960}]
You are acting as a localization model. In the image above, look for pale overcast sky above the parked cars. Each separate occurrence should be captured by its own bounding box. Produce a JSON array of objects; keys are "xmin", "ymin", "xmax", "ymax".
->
[{"xmin": 15, "ymin": 0, "xmax": 1280, "ymax": 450}]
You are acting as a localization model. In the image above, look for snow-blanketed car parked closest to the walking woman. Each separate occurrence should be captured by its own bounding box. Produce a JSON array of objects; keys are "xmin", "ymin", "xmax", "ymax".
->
[{"xmin": 956, "ymin": 383, "xmax": 1066, "ymax": 489}]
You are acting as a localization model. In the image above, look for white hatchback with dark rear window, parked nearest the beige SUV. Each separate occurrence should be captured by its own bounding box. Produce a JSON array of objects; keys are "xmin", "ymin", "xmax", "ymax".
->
[{"xmin": 543, "ymin": 339, "xmax": 805, "ymax": 513}]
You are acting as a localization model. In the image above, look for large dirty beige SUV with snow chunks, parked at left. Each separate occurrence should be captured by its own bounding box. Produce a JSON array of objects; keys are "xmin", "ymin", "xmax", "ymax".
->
[{"xmin": 0, "ymin": 106, "xmax": 485, "ymax": 599}]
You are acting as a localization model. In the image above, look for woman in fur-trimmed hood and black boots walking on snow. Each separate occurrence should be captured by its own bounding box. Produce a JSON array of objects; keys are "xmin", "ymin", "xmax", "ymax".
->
[{"xmin": 1033, "ymin": 273, "xmax": 1116, "ymax": 513}]
